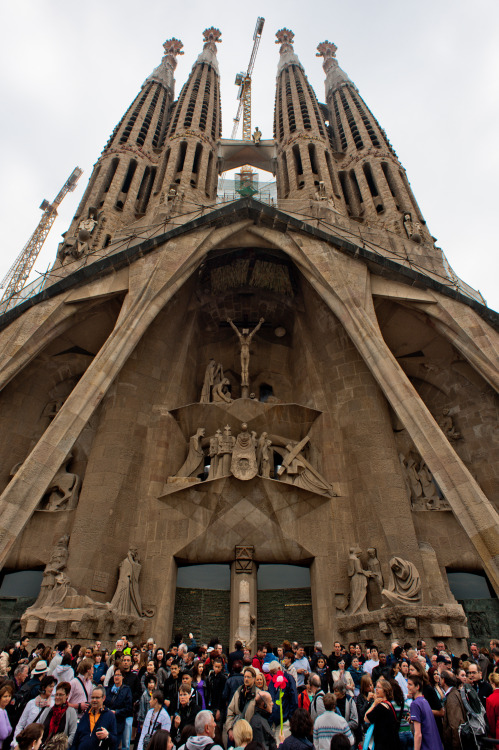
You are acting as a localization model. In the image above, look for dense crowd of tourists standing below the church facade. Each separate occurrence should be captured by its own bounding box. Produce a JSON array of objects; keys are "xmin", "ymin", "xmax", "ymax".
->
[{"xmin": 0, "ymin": 634, "xmax": 499, "ymax": 750}]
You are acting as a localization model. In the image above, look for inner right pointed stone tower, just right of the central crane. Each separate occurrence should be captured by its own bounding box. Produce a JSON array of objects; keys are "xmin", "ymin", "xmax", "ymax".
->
[{"xmin": 274, "ymin": 29, "xmax": 342, "ymax": 207}]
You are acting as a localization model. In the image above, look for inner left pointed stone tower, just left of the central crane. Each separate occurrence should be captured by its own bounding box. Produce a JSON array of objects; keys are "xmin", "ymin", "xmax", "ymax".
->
[{"xmin": 153, "ymin": 27, "xmax": 222, "ymax": 212}]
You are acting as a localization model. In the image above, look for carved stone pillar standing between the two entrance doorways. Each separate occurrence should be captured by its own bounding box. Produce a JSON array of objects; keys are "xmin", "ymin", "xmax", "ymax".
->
[{"xmin": 229, "ymin": 545, "xmax": 257, "ymax": 650}]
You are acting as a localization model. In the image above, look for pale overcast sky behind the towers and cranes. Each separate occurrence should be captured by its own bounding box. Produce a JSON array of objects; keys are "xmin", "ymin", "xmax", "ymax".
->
[{"xmin": 0, "ymin": 0, "xmax": 499, "ymax": 310}]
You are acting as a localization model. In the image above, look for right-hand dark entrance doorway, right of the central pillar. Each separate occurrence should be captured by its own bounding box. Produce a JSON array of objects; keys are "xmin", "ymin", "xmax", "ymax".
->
[{"xmin": 257, "ymin": 564, "xmax": 314, "ymax": 646}]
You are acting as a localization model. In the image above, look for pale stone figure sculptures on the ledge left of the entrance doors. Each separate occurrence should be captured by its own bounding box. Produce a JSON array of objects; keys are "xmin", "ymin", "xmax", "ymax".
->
[{"xmin": 28, "ymin": 534, "xmax": 150, "ymax": 617}]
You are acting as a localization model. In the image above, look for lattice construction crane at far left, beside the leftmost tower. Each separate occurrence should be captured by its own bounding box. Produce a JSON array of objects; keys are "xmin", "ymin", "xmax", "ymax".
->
[{"xmin": 0, "ymin": 167, "xmax": 83, "ymax": 301}]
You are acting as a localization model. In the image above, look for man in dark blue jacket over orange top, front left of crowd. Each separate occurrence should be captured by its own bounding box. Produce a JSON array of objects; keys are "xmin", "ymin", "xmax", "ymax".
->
[{"xmin": 71, "ymin": 687, "xmax": 118, "ymax": 750}]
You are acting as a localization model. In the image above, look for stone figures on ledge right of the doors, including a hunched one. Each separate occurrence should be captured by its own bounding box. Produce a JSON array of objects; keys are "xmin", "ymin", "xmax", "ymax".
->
[{"xmin": 343, "ymin": 547, "xmax": 421, "ymax": 615}]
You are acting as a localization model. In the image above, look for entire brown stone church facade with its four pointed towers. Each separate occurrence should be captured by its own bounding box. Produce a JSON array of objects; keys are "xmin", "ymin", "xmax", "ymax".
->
[{"xmin": 0, "ymin": 28, "xmax": 499, "ymax": 648}]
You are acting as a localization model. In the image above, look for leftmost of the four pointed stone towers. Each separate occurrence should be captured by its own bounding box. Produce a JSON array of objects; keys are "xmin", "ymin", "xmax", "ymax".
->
[{"xmin": 58, "ymin": 39, "xmax": 184, "ymax": 263}]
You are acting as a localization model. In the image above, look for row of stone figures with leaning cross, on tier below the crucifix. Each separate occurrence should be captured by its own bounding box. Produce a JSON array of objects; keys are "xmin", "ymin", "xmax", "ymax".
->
[{"xmin": 174, "ymin": 422, "xmax": 334, "ymax": 496}]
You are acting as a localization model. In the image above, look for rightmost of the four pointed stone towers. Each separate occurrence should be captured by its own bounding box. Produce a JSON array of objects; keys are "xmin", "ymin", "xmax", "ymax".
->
[{"xmin": 317, "ymin": 41, "xmax": 433, "ymax": 244}]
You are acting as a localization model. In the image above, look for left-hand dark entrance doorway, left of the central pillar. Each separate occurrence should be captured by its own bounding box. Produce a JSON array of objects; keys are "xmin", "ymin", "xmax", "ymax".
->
[{"xmin": 173, "ymin": 564, "xmax": 230, "ymax": 648}]
